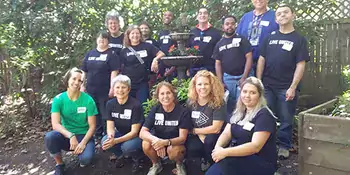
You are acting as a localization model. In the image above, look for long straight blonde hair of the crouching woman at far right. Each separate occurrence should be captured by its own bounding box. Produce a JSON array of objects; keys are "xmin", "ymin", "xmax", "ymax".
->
[{"xmin": 230, "ymin": 77, "xmax": 271, "ymax": 123}]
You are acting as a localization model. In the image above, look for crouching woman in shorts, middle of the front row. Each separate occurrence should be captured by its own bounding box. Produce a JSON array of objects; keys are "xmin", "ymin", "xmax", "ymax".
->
[{"xmin": 140, "ymin": 82, "xmax": 191, "ymax": 175}]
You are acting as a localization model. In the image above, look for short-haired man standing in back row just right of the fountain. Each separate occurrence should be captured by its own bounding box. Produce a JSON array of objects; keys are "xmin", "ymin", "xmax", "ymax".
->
[{"xmin": 189, "ymin": 7, "xmax": 221, "ymax": 77}]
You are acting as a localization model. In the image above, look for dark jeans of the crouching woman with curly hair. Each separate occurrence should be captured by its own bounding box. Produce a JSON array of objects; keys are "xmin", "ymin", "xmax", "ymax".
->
[{"xmin": 186, "ymin": 134, "xmax": 220, "ymax": 162}]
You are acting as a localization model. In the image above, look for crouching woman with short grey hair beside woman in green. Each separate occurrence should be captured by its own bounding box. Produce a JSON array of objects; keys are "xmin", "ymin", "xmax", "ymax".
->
[{"xmin": 102, "ymin": 75, "xmax": 144, "ymax": 172}]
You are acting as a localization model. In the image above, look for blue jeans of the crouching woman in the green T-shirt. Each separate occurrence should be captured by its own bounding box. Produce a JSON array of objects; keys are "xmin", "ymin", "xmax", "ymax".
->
[{"xmin": 44, "ymin": 131, "xmax": 95, "ymax": 165}]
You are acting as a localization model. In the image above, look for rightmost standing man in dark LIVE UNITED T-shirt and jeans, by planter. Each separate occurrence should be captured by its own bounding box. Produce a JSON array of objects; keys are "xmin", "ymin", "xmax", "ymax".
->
[{"xmin": 257, "ymin": 5, "xmax": 310, "ymax": 158}]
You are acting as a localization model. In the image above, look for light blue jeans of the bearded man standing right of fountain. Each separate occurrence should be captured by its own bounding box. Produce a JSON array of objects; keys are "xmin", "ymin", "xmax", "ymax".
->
[{"xmin": 223, "ymin": 73, "xmax": 242, "ymax": 115}]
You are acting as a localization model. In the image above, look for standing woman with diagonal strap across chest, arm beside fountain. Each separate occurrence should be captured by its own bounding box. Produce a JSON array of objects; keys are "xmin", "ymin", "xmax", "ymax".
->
[{"xmin": 120, "ymin": 25, "xmax": 164, "ymax": 104}]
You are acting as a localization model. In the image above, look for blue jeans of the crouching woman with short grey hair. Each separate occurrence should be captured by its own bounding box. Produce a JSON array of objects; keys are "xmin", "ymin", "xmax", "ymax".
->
[{"xmin": 101, "ymin": 132, "xmax": 142, "ymax": 159}]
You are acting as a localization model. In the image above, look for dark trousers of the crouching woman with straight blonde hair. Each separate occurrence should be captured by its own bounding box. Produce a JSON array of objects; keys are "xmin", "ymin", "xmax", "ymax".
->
[{"xmin": 205, "ymin": 155, "xmax": 276, "ymax": 175}]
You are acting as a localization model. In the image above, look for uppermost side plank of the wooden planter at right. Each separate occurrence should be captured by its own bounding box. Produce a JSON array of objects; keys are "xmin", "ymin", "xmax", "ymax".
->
[{"xmin": 301, "ymin": 113, "xmax": 350, "ymax": 145}]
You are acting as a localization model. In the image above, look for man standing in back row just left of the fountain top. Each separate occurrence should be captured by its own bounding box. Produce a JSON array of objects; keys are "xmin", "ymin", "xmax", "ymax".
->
[{"xmin": 158, "ymin": 11, "xmax": 176, "ymax": 81}]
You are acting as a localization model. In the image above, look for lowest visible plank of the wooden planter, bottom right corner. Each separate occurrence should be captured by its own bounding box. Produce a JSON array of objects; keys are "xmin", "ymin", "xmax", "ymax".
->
[{"xmin": 298, "ymin": 164, "xmax": 350, "ymax": 175}]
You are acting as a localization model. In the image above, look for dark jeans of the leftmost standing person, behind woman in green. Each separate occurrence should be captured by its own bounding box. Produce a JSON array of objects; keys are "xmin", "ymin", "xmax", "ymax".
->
[{"xmin": 89, "ymin": 94, "xmax": 108, "ymax": 136}]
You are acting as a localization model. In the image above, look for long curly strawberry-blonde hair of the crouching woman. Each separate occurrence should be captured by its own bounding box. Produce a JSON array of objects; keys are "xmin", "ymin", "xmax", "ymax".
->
[{"xmin": 188, "ymin": 70, "xmax": 224, "ymax": 109}]
